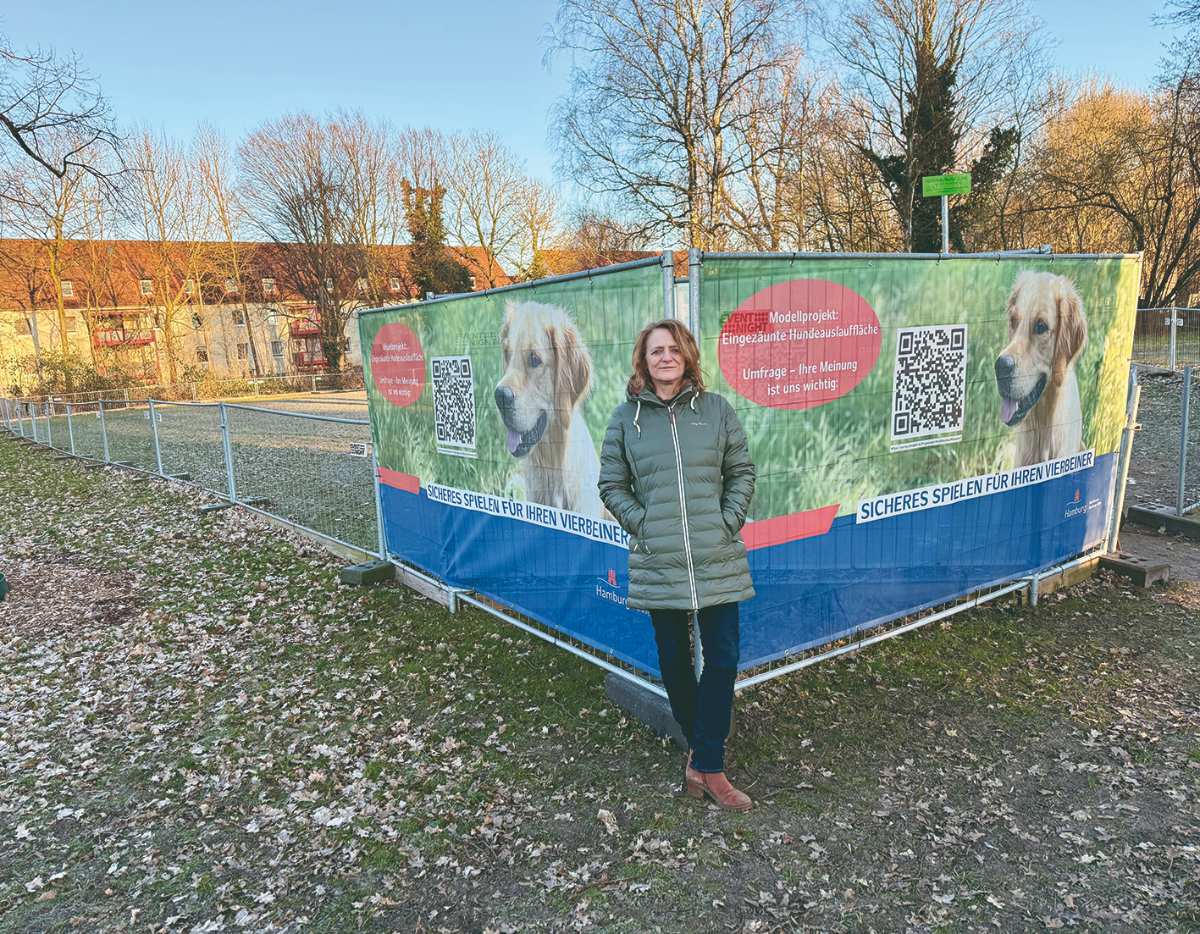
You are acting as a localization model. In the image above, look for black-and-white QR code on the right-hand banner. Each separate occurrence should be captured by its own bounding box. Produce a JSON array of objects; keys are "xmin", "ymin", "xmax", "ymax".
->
[{"xmin": 892, "ymin": 324, "xmax": 967, "ymax": 448}]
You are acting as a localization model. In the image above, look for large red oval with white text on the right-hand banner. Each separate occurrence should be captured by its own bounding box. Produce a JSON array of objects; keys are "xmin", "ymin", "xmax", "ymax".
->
[{"xmin": 716, "ymin": 279, "xmax": 882, "ymax": 408}]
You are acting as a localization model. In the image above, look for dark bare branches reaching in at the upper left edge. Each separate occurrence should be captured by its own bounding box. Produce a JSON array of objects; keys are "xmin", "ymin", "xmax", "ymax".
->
[{"xmin": 0, "ymin": 36, "xmax": 121, "ymax": 196}]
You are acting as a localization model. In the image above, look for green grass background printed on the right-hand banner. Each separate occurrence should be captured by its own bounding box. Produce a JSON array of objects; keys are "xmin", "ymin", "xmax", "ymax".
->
[{"xmin": 701, "ymin": 257, "xmax": 1138, "ymax": 519}]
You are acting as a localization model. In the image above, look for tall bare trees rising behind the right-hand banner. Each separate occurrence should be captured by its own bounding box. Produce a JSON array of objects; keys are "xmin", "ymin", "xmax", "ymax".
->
[{"xmin": 552, "ymin": 0, "xmax": 1200, "ymax": 305}]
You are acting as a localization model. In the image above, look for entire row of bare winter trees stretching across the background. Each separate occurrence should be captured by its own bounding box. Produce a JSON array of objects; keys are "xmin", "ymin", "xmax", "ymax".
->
[{"xmin": 0, "ymin": 0, "xmax": 1200, "ymax": 379}]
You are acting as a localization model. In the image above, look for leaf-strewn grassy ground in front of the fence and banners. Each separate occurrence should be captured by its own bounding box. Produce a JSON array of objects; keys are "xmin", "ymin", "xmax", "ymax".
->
[{"xmin": 0, "ymin": 439, "xmax": 1200, "ymax": 932}]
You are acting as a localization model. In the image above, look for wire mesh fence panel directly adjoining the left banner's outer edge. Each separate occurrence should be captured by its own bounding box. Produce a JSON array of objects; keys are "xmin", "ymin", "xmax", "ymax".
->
[{"xmin": 226, "ymin": 405, "xmax": 378, "ymax": 552}]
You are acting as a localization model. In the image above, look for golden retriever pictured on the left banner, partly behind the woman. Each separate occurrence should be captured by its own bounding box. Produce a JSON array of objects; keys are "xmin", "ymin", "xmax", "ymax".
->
[{"xmin": 496, "ymin": 301, "xmax": 608, "ymax": 519}]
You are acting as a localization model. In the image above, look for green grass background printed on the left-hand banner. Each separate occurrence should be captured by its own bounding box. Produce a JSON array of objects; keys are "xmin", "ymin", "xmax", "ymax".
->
[{"xmin": 360, "ymin": 261, "xmax": 662, "ymax": 498}]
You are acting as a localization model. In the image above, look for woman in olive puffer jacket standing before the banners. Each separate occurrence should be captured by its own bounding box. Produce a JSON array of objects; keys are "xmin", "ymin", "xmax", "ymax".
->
[{"xmin": 599, "ymin": 319, "xmax": 755, "ymax": 810}]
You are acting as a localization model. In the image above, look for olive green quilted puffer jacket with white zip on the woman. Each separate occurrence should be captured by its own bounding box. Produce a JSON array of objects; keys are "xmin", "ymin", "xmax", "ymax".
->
[{"xmin": 599, "ymin": 385, "xmax": 755, "ymax": 610}]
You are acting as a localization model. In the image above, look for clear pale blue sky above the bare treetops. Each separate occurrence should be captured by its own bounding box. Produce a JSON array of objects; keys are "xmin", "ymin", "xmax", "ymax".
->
[{"xmin": 0, "ymin": 0, "xmax": 1180, "ymax": 186}]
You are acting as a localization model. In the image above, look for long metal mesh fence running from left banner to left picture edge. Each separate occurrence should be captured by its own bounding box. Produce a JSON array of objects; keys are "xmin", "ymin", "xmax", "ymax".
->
[{"xmin": 0, "ymin": 399, "xmax": 383, "ymax": 557}]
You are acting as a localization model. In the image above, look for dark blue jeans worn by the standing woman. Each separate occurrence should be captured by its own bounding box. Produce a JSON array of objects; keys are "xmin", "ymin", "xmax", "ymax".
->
[{"xmin": 650, "ymin": 603, "xmax": 738, "ymax": 772}]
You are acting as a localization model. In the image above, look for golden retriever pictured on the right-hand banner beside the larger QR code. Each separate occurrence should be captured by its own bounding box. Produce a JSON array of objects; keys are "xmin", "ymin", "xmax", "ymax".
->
[{"xmin": 996, "ymin": 270, "xmax": 1087, "ymax": 467}]
